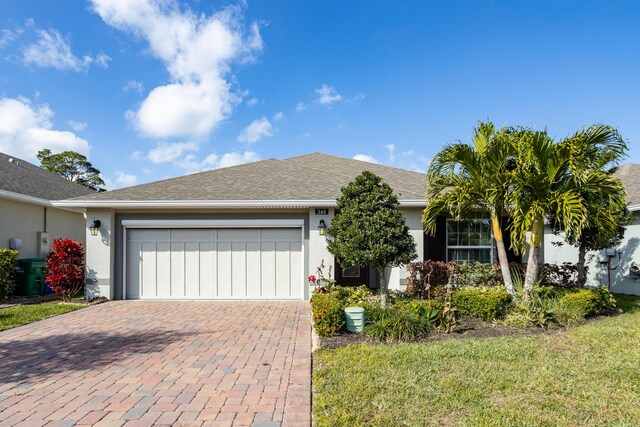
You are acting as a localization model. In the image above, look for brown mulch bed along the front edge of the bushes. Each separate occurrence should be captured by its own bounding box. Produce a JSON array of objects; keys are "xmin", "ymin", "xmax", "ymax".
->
[{"xmin": 321, "ymin": 316, "xmax": 562, "ymax": 349}]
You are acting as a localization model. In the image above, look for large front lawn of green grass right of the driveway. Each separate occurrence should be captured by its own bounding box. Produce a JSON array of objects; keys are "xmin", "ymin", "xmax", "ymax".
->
[{"xmin": 313, "ymin": 296, "xmax": 640, "ymax": 426}]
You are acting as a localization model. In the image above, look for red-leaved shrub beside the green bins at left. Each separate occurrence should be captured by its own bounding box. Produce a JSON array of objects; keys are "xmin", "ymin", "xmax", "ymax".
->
[{"xmin": 46, "ymin": 239, "xmax": 84, "ymax": 301}]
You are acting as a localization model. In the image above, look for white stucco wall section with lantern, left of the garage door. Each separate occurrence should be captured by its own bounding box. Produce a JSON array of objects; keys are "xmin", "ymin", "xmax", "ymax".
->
[{"xmin": 84, "ymin": 209, "xmax": 115, "ymax": 299}]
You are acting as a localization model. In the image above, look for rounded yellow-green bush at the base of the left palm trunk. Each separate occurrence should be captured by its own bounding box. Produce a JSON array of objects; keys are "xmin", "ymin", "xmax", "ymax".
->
[{"xmin": 452, "ymin": 286, "xmax": 511, "ymax": 320}]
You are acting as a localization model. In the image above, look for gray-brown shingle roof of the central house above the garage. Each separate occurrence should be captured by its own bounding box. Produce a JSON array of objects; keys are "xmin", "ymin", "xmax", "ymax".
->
[{"xmin": 57, "ymin": 153, "xmax": 427, "ymax": 207}]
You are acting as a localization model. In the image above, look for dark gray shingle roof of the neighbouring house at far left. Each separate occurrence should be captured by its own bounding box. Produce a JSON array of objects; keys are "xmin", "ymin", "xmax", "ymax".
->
[{"xmin": 0, "ymin": 153, "xmax": 93, "ymax": 200}]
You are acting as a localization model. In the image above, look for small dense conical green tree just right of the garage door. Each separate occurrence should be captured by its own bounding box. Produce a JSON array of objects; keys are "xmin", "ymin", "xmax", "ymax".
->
[{"xmin": 327, "ymin": 171, "xmax": 417, "ymax": 307}]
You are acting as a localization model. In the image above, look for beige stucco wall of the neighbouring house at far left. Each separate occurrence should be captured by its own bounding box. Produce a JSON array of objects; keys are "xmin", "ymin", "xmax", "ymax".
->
[{"xmin": 0, "ymin": 199, "xmax": 85, "ymax": 258}]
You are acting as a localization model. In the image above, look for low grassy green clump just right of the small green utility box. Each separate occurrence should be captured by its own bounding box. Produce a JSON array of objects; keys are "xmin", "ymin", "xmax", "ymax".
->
[{"xmin": 364, "ymin": 308, "xmax": 429, "ymax": 342}]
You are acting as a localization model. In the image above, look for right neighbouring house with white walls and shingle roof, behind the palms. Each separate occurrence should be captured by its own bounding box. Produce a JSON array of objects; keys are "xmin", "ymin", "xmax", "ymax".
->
[{"xmin": 543, "ymin": 163, "xmax": 640, "ymax": 295}]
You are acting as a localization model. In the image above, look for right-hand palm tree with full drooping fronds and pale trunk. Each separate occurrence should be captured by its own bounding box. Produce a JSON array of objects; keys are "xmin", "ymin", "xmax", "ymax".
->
[{"xmin": 507, "ymin": 125, "xmax": 626, "ymax": 294}]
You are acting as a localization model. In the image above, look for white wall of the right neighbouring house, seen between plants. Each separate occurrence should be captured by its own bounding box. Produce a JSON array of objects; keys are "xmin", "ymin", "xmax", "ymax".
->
[{"xmin": 544, "ymin": 213, "xmax": 640, "ymax": 295}]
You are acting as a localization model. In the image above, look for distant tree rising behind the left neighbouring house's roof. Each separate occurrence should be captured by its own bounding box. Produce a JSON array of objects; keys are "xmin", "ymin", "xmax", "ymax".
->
[{"xmin": 36, "ymin": 148, "xmax": 106, "ymax": 191}]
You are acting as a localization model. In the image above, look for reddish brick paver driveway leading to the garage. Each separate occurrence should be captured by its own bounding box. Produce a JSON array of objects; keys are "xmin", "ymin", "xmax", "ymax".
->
[{"xmin": 0, "ymin": 301, "xmax": 311, "ymax": 426}]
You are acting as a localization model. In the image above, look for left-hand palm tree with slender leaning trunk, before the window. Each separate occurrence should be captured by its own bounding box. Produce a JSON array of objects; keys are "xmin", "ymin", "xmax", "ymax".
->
[{"xmin": 422, "ymin": 122, "xmax": 515, "ymax": 295}]
